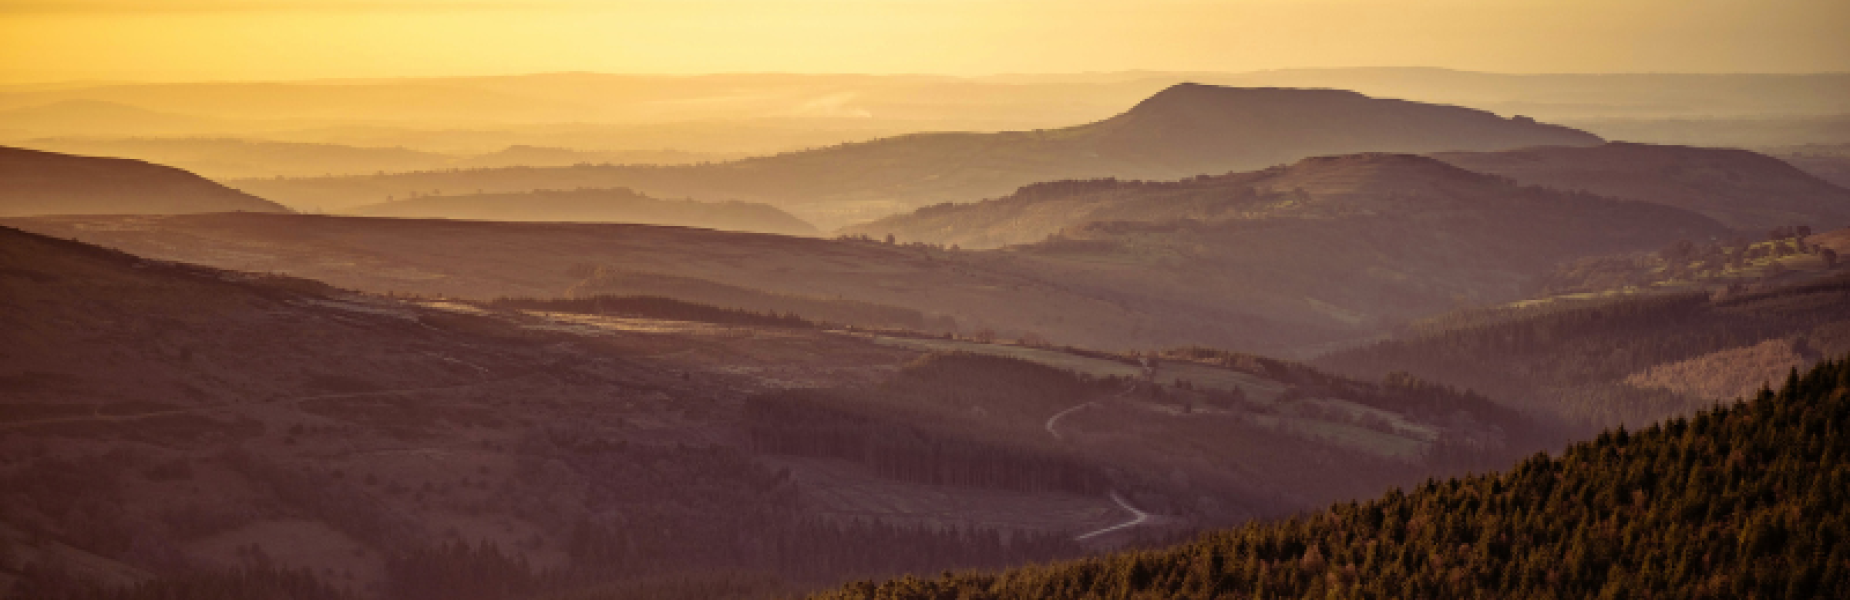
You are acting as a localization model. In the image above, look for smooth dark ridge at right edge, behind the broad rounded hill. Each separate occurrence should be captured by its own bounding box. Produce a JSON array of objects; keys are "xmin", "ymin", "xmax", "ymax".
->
[{"xmin": 1434, "ymin": 143, "xmax": 1850, "ymax": 233}]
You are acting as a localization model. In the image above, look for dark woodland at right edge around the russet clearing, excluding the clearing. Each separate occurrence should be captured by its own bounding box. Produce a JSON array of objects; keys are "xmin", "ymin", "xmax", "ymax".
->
[{"xmin": 1314, "ymin": 276, "xmax": 1850, "ymax": 430}]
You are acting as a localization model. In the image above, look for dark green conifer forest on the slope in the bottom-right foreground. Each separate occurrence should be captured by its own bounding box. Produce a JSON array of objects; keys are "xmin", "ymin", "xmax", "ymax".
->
[{"xmin": 816, "ymin": 361, "xmax": 1850, "ymax": 600}]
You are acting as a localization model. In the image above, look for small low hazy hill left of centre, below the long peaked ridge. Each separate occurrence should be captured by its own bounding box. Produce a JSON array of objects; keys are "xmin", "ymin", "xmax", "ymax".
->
[{"xmin": 344, "ymin": 187, "xmax": 816, "ymax": 235}]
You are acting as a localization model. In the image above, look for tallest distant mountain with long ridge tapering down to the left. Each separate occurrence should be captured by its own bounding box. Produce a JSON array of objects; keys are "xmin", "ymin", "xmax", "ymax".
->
[{"xmin": 223, "ymin": 83, "xmax": 1600, "ymax": 228}]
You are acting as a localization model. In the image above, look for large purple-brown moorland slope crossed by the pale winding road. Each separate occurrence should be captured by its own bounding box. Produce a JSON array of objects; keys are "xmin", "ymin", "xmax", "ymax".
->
[{"xmin": 0, "ymin": 230, "xmax": 1558, "ymax": 600}]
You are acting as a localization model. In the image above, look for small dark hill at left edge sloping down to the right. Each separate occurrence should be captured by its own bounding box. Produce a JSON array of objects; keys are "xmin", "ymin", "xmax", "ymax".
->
[{"xmin": 0, "ymin": 146, "xmax": 289, "ymax": 217}]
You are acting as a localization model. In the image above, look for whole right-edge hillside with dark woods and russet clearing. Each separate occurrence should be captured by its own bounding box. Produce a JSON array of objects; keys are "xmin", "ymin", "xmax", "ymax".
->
[{"xmin": 1314, "ymin": 270, "xmax": 1850, "ymax": 430}]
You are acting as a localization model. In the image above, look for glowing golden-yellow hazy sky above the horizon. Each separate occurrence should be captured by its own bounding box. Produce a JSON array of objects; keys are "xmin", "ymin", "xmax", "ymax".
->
[{"xmin": 0, "ymin": 0, "xmax": 1850, "ymax": 81}]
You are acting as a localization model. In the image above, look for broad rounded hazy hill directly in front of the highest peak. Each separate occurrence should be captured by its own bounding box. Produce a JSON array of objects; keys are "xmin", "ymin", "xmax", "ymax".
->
[{"xmin": 832, "ymin": 154, "xmax": 1728, "ymax": 348}]
